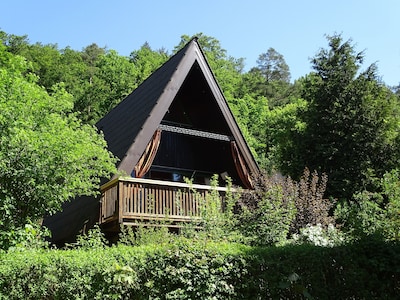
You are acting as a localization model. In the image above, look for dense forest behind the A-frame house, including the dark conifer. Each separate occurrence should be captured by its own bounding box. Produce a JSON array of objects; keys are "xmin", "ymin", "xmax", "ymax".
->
[{"xmin": 0, "ymin": 32, "xmax": 400, "ymax": 189}]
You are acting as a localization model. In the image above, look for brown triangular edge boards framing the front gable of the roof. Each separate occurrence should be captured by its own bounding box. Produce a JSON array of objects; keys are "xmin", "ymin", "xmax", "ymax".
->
[{"xmin": 99, "ymin": 37, "xmax": 259, "ymax": 175}]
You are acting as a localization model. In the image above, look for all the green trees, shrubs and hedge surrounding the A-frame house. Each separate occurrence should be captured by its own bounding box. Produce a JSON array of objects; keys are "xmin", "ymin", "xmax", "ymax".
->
[{"xmin": 0, "ymin": 32, "xmax": 400, "ymax": 299}]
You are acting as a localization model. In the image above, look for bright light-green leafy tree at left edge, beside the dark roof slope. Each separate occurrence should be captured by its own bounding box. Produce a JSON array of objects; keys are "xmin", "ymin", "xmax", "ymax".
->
[{"xmin": 0, "ymin": 44, "xmax": 115, "ymax": 235}]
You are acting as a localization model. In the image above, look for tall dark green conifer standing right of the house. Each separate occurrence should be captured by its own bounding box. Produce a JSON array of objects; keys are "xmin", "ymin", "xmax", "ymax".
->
[{"xmin": 284, "ymin": 35, "xmax": 400, "ymax": 199}]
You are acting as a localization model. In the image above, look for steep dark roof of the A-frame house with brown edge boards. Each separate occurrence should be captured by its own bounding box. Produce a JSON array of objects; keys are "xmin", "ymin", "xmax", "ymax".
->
[{"xmin": 96, "ymin": 39, "xmax": 258, "ymax": 174}]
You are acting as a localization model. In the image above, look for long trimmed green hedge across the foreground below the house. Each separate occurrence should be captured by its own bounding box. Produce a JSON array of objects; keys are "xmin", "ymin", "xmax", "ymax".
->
[{"xmin": 0, "ymin": 240, "xmax": 400, "ymax": 299}]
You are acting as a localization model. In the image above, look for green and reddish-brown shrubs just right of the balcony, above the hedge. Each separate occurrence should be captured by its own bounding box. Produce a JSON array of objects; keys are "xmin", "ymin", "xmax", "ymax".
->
[{"xmin": 237, "ymin": 169, "xmax": 335, "ymax": 245}]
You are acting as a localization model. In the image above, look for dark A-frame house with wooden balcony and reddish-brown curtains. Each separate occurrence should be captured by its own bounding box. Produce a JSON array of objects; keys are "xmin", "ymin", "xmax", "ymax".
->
[{"xmin": 45, "ymin": 39, "xmax": 259, "ymax": 241}]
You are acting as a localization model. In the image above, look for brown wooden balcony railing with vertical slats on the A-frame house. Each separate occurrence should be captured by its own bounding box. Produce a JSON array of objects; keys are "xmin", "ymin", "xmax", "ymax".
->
[{"xmin": 99, "ymin": 177, "xmax": 231, "ymax": 224}]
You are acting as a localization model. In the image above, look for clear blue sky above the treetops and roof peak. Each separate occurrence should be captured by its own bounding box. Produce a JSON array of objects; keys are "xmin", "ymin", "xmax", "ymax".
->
[{"xmin": 0, "ymin": 0, "xmax": 400, "ymax": 86}]
